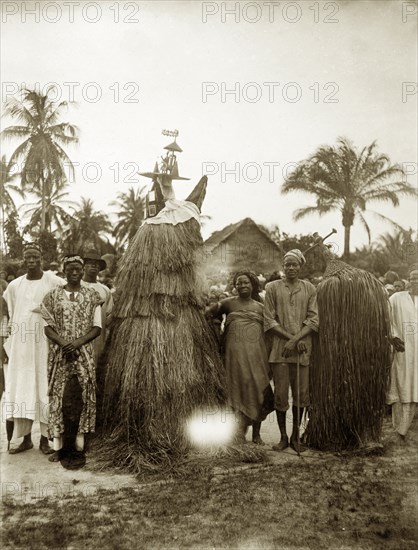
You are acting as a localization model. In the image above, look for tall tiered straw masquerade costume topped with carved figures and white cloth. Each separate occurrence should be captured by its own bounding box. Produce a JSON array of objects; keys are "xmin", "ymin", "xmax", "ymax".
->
[{"xmin": 104, "ymin": 133, "xmax": 224, "ymax": 471}]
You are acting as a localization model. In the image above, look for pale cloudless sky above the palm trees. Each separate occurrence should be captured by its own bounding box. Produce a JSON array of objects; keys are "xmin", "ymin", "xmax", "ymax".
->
[{"xmin": 0, "ymin": 0, "xmax": 418, "ymax": 254}]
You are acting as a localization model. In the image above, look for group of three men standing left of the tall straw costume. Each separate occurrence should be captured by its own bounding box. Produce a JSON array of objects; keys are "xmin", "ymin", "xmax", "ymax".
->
[{"xmin": 2, "ymin": 243, "xmax": 113, "ymax": 469}]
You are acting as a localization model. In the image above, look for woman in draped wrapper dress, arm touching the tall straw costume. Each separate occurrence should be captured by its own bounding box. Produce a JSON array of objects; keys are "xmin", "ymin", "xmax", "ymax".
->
[{"xmin": 207, "ymin": 271, "xmax": 274, "ymax": 444}]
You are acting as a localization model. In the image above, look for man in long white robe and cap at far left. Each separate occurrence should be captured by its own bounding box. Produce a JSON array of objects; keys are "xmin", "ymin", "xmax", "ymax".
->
[{"xmin": 3, "ymin": 243, "xmax": 65, "ymax": 454}]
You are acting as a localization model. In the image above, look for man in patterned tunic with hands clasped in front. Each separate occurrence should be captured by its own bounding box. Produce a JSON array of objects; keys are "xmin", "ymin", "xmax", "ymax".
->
[{"xmin": 41, "ymin": 255, "xmax": 102, "ymax": 469}]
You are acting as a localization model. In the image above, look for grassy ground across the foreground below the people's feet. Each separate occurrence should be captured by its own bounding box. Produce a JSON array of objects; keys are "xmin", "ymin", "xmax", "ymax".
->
[{"xmin": 2, "ymin": 421, "xmax": 418, "ymax": 550}]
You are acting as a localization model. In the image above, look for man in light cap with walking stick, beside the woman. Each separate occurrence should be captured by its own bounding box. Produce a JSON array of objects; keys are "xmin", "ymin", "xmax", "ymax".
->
[{"xmin": 264, "ymin": 249, "xmax": 318, "ymax": 452}]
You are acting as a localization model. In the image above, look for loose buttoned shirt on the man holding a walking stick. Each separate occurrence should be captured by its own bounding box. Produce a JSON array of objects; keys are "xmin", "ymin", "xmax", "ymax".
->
[{"xmin": 264, "ymin": 279, "xmax": 318, "ymax": 365}]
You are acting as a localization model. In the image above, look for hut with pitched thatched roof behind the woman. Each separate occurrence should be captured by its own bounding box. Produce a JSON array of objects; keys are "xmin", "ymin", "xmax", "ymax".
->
[{"xmin": 204, "ymin": 218, "xmax": 282, "ymax": 273}]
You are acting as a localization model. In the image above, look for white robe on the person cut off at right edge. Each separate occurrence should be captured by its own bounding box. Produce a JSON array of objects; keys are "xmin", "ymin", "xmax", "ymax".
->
[{"xmin": 388, "ymin": 291, "xmax": 418, "ymax": 404}]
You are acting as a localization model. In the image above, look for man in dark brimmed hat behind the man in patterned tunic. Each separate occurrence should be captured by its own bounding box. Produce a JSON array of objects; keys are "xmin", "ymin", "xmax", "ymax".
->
[{"xmin": 81, "ymin": 250, "xmax": 113, "ymax": 365}]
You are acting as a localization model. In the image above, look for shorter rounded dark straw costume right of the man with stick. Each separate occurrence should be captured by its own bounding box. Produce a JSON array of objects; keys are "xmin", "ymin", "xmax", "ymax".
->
[{"xmin": 305, "ymin": 230, "xmax": 391, "ymax": 451}]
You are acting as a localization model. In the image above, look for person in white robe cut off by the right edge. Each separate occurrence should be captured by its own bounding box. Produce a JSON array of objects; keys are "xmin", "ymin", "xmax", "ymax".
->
[{"xmin": 388, "ymin": 271, "xmax": 418, "ymax": 440}]
